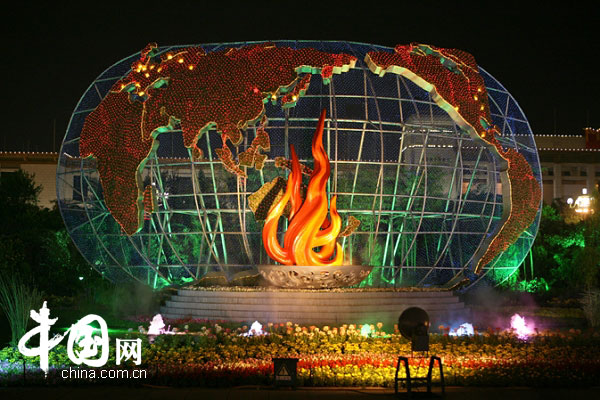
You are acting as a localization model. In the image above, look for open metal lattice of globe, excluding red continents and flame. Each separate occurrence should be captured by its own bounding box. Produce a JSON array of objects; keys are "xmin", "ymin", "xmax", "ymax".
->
[{"xmin": 57, "ymin": 41, "xmax": 541, "ymax": 287}]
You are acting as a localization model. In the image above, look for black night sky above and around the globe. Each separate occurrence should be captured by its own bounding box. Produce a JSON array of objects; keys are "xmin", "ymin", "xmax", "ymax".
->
[{"xmin": 0, "ymin": 0, "xmax": 600, "ymax": 151}]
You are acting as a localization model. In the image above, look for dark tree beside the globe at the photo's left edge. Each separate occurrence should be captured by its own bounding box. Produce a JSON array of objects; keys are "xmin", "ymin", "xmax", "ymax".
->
[{"xmin": 0, "ymin": 170, "xmax": 101, "ymax": 296}]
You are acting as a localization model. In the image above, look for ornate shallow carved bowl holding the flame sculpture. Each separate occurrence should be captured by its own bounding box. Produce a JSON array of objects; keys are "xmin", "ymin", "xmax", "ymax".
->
[{"xmin": 258, "ymin": 265, "xmax": 373, "ymax": 289}]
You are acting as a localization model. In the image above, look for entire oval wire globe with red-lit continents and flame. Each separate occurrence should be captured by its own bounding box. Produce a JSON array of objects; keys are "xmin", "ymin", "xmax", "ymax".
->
[{"xmin": 57, "ymin": 41, "xmax": 541, "ymax": 288}]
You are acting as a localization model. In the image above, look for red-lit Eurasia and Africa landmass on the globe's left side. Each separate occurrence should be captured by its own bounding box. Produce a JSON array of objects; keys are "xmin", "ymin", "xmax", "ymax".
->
[{"xmin": 79, "ymin": 43, "xmax": 356, "ymax": 235}]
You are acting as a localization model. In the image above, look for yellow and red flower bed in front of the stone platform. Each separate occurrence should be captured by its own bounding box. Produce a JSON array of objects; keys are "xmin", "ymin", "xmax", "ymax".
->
[{"xmin": 0, "ymin": 321, "xmax": 600, "ymax": 387}]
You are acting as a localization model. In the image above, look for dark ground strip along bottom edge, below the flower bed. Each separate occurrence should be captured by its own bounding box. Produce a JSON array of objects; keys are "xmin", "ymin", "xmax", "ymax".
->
[{"xmin": 0, "ymin": 386, "xmax": 600, "ymax": 400}]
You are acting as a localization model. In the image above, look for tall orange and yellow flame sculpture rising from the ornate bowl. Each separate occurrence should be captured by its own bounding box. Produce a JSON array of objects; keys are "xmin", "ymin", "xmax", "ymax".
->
[{"xmin": 262, "ymin": 110, "xmax": 344, "ymax": 266}]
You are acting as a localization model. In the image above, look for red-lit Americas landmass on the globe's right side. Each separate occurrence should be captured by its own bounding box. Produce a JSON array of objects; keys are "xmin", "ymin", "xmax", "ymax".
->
[{"xmin": 365, "ymin": 43, "xmax": 542, "ymax": 273}]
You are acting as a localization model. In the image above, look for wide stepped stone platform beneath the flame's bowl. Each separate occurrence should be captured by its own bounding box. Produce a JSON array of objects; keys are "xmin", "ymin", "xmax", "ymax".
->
[{"xmin": 161, "ymin": 287, "xmax": 470, "ymax": 329}]
